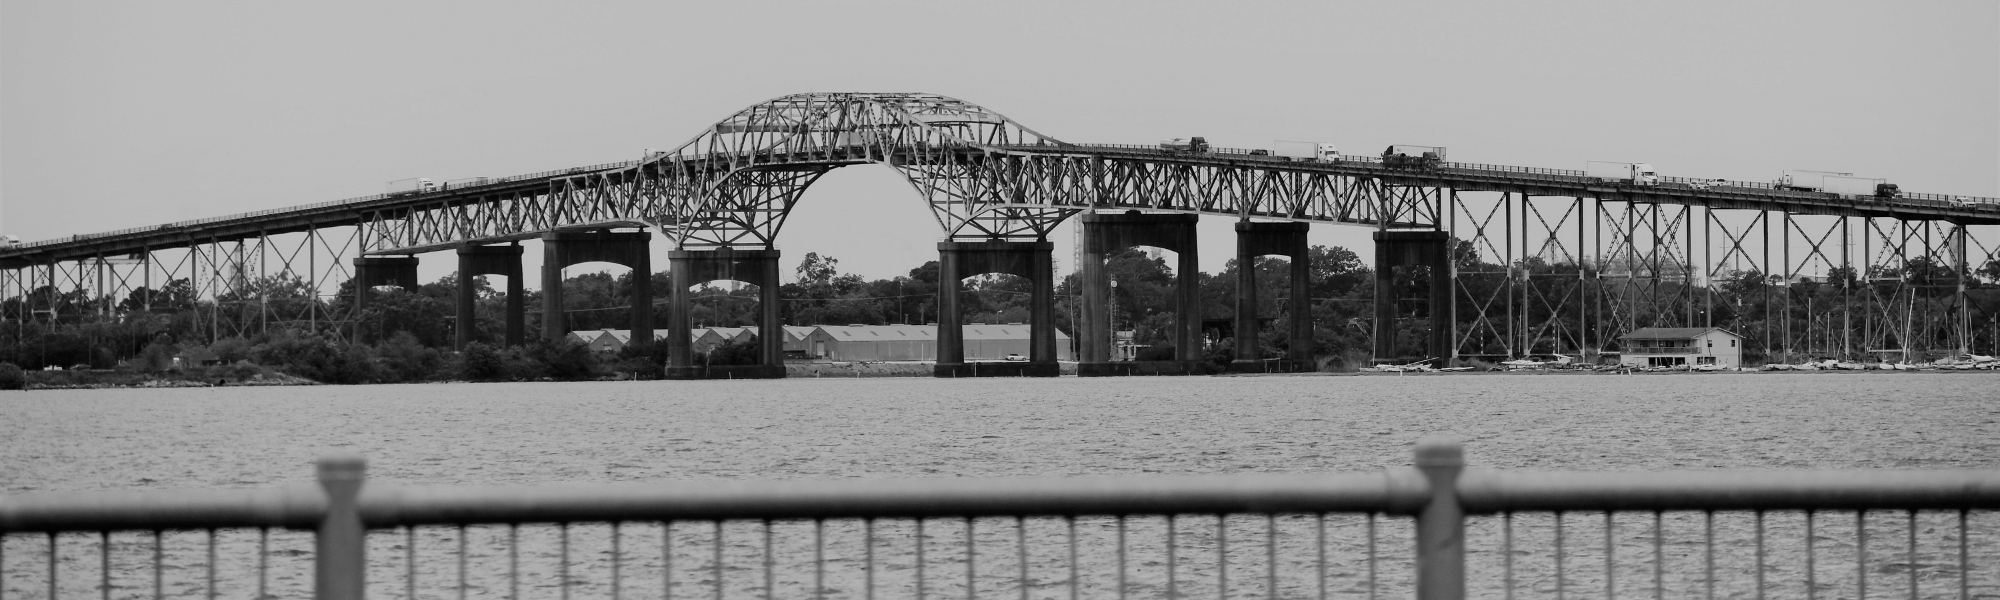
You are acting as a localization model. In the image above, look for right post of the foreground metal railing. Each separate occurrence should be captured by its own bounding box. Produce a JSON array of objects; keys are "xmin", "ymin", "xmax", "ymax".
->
[{"xmin": 1416, "ymin": 436, "xmax": 1466, "ymax": 600}]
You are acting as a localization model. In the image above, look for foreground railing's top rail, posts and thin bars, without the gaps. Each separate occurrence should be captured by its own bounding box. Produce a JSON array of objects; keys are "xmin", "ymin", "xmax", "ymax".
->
[{"xmin": 0, "ymin": 440, "xmax": 2000, "ymax": 600}]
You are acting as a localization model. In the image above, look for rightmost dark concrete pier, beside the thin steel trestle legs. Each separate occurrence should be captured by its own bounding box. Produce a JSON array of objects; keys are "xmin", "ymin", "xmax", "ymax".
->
[{"xmin": 1374, "ymin": 230, "xmax": 1454, "ymax": 362}]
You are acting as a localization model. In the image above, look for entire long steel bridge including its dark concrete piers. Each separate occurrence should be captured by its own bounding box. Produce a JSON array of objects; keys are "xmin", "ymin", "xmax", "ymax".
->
[{"xmin": 0, "ymin": 94, "xmax": 2000, "ymax": 378}]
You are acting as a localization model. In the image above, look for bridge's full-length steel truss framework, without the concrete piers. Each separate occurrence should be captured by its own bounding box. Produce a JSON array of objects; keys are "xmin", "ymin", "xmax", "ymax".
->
[{"xmin": 0, "ymin": 94, "xmax": 2000, "ymax": 366}]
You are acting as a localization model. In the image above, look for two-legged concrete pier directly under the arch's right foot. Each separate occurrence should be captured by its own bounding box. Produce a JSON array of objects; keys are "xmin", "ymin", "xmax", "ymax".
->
[{"xmin": 934, "ymin": 242, "xmax": 1064, "ymax": 378}]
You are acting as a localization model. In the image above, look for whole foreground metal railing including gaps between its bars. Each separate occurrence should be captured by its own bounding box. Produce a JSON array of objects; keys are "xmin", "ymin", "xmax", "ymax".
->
[{"xmin": 0, "ymin": 440, "xmax": 2000, "ymax": 600}]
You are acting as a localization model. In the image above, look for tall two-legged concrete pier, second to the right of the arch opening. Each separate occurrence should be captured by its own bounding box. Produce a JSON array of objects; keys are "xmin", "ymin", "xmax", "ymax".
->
[{"xmin": 1076, "ymin": 210, "xmax": 1202, "ymax": 376}]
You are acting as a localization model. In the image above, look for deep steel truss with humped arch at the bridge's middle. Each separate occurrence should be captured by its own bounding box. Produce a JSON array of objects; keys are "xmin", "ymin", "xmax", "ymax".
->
[{"xmin": 516, "ymin": 94, "xmax": 1440, "ymax": 248}]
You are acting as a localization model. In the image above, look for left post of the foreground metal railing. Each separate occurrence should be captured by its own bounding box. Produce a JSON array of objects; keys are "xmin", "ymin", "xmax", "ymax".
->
[{"xmin": 312, "ymin": 452, "xmax": 368, "ymax": 600}]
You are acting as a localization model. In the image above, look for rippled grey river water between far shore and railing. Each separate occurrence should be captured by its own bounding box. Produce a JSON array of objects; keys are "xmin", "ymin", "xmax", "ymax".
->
[{"xmin": 0, "ymin": 372, "xmax": 2000, "ymax": 598}]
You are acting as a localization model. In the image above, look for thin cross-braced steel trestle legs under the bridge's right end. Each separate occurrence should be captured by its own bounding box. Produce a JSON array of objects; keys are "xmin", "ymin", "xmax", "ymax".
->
[{"xmin": 1446, "ymin": 192, "xmax": 2000, "ymax": 362}]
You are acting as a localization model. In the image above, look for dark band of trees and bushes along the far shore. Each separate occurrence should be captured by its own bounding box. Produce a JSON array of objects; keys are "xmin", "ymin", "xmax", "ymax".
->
[{"xmin": 0, "ymin": 244, "xmax": 2000, "ymax": 390}]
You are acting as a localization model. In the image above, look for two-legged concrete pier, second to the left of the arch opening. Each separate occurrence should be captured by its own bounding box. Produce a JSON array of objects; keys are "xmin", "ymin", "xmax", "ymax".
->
[{"xmin": 542, "ymin": 232, "xmax": 652, "ymax": 346}]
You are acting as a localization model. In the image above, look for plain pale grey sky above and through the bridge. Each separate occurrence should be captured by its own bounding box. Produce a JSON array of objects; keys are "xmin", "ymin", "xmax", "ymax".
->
[{"xmin": 0, "ymin": 0, "xmax": 2000, "ymax": 286}]
